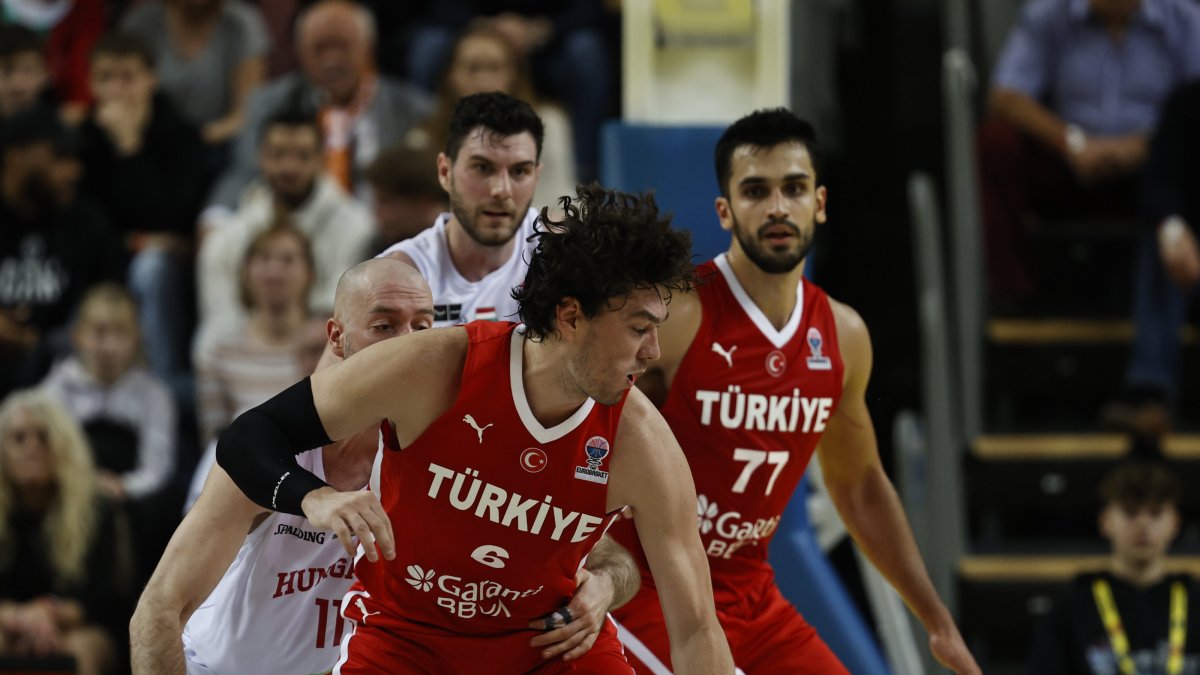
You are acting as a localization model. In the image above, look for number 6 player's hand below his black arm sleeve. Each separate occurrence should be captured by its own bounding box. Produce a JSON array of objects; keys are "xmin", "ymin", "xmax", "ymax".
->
[{"xmin": 300, "ymin": 488, "xmax": 396, "ymax": 562}]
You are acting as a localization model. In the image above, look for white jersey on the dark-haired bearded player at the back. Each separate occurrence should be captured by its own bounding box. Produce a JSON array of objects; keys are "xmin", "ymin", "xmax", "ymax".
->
[{"xmin": 378, "ymin": 209, "xmax": 538, "ymax": 328}]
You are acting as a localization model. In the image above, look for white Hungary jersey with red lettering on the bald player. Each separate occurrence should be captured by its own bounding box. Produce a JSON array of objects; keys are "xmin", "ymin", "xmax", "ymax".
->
[{"xmin": 184, "ymin": 448, "xmax": 354, "ymax": 675}]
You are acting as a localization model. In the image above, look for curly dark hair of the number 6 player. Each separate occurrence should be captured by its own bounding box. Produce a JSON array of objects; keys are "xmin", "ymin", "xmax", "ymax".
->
[{"xmin": 512, "ymin": 183, "xmax": 695, "ymax": 340}]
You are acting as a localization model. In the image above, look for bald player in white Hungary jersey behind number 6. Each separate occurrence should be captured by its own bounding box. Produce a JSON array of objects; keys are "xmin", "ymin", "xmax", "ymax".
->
[{"xmin": 130, "ymin": 258, "xmax": 433, "ymax": 675}]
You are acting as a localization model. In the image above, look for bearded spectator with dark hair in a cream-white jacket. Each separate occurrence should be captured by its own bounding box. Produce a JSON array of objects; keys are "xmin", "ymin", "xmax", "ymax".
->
[{"xmin": 197, "ymin": 110, "xmax": 374, "ymax": 345}]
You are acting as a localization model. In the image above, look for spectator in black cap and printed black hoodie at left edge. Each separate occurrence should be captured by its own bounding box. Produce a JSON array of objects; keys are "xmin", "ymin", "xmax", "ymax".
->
[{"xmin": 0, "ymin": 109, "xmax": 120, "ymax": 395}]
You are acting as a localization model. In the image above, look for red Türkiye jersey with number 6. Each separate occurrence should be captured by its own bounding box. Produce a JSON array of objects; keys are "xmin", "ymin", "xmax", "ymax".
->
[{"xmin": 347, "ymin": 321, "xmax": 624, "ymax": 671}]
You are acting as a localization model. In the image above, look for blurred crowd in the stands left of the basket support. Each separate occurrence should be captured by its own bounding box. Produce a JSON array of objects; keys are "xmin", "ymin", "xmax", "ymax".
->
[{"xmin": 0, "ymin": 0, "xmax": 614, "ymax": 673}]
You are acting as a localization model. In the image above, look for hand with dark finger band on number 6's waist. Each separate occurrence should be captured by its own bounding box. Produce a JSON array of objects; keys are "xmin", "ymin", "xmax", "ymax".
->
[{"xmin": 529, "ymin": 568, "xmax": 613, "ymax": 661}]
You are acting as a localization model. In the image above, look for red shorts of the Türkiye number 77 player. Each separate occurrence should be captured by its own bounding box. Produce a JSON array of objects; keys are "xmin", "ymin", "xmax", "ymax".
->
[{"xmin": 612, "ymin": 583, "xmax": 848, "ymax": 675}]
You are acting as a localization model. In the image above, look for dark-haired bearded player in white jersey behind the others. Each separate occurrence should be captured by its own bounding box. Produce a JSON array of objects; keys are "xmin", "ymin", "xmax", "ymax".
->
[{"xmin": 380, "ymin": 92, "xmax": 542, "ymax": 327}]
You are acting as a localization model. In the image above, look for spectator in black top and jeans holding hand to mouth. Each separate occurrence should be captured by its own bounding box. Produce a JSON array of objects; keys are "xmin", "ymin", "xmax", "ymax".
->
[{"xmin": 80, "ymin": 34, "xmax": 204, "ymax": 401}]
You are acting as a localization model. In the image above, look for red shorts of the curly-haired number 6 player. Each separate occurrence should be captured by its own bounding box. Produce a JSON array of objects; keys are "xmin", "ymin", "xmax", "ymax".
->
[{"xmin": 334, "ymin": 607, "xmax": 634, "ymax": 675}]
